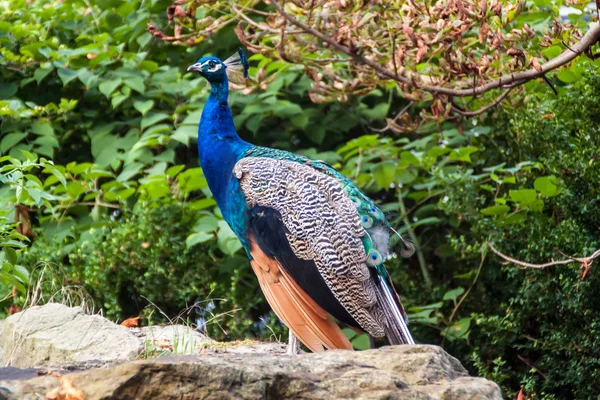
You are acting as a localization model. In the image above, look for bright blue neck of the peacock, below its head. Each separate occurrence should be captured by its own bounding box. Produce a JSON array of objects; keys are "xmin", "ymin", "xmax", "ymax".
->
[{"xmin": 198, "ymin": 78, "xmax": 251, "ymax": 214}]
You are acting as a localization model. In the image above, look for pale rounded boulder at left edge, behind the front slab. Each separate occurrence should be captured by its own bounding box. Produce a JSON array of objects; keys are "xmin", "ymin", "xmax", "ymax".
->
[{"xmin": 0, "ymin": 303, "xmax": 143, "ymax": 368}]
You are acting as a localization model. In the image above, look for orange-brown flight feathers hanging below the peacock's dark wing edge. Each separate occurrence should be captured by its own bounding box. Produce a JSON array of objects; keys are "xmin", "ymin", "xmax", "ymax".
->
[{"xmin": 250, "ymin": 238, "xmax": 352, "ymax": 352}]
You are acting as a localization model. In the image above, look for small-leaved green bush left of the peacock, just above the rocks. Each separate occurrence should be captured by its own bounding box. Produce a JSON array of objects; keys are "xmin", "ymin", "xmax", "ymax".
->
[{"xmin": 25, "ymin": 201, "xmax": 281, "ymax": 339}]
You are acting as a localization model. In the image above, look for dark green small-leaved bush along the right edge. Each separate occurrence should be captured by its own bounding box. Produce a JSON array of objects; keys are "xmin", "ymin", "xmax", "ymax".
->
[{"xmin": 444, "ymin": 75, "xmax": 600, "ymax": 399}]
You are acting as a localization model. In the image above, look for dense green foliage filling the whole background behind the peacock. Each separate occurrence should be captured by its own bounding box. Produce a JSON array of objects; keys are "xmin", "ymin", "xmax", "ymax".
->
[{"xmin": 0, "ymin": 0, "xmax": 600, "ymax": 399}]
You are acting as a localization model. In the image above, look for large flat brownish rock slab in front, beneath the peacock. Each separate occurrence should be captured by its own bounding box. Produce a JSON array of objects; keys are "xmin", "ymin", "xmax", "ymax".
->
[{"xmin": 0, "ymin": 345, "xmax": 502, "ymax": 400}]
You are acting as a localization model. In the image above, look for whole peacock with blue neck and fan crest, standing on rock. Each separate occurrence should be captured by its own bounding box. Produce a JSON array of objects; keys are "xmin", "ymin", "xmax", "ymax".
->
[{"xmin": 187, "ymin": 49, "xmax": 414, "ymax": 352}]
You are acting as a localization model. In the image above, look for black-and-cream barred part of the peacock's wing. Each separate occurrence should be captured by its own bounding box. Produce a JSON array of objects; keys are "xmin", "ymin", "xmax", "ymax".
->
[{"xmin": 234, "ymin": 157, "xmax": 385, "ymax": 337}]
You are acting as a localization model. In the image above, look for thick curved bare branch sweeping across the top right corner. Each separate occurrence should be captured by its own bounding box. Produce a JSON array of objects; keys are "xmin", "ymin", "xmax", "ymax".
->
[{"xmin": 271, "ymin": 0, "xmax": 600, "ymax": 97}]
